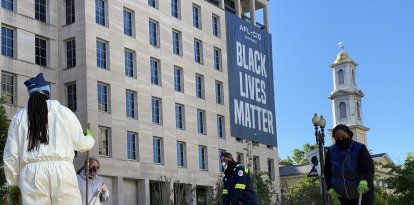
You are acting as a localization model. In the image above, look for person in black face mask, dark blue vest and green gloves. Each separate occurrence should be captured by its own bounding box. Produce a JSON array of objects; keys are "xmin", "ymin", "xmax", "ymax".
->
[{"xmin": 324, "ymin": 125, "xmax": 374, "ymax": 205}]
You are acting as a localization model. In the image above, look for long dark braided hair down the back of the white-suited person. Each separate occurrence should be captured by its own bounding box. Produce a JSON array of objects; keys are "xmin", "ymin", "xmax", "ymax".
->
[{"xmin": 27, "ymin": 91, "xmax": 49, "ymax": 152}]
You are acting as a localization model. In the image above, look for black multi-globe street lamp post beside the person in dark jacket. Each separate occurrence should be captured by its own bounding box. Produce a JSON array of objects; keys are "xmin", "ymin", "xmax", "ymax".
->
[{"xmin": 312, "ymin": 113, "xmax": 326, "ymax": 205}]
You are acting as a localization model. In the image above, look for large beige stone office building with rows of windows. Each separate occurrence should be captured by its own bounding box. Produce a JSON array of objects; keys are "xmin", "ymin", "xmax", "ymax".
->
[{"xmin": 0, "ymin": 0, "xmax": 279, "ymax": 204}]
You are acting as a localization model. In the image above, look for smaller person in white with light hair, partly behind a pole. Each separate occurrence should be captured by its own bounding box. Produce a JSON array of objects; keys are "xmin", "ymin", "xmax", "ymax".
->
[{"xmin": 77, "ymin": 157, "xmax": 109, "ymax": 205}]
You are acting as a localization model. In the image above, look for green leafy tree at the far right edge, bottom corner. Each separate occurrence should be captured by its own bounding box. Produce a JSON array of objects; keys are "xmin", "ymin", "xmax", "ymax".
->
[{"xmin": 384, "ymin": 153, "xmax": 414, "ymax": 204}]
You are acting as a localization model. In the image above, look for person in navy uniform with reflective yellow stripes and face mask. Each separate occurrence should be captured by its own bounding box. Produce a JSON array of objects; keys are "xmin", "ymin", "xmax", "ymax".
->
[{"xmin": 220, "ymin": 152, "xmax": 259, "ymax": 205}]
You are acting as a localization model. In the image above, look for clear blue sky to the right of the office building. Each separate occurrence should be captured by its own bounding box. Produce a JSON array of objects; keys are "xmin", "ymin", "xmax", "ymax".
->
[{"xmin": 269, "ymin": 0, "xmax": 414, "ymax": 163}]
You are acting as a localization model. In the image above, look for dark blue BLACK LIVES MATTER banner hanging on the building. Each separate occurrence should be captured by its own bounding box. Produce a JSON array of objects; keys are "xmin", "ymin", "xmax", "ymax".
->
[{"xmin": 226, "ymin": 11, "xmax": 277, "ymax": 146}]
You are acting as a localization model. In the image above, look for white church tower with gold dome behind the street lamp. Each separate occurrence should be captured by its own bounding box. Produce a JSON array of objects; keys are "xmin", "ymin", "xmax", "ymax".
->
[{"xmin": 329, "ymin": 43, "xmax": 369, "ymax": 145}]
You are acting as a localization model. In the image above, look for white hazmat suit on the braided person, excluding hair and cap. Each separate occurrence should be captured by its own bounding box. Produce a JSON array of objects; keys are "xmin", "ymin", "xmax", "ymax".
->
[{"xmin": 3, "ymin": 100, "xmax": 95, "ymax": 205}]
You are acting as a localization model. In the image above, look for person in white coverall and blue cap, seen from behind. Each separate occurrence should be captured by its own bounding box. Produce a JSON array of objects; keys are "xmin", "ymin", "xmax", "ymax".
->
[{"xmin": 3, "ymin": 73, "xmax": 95, "ymax": 205}]
